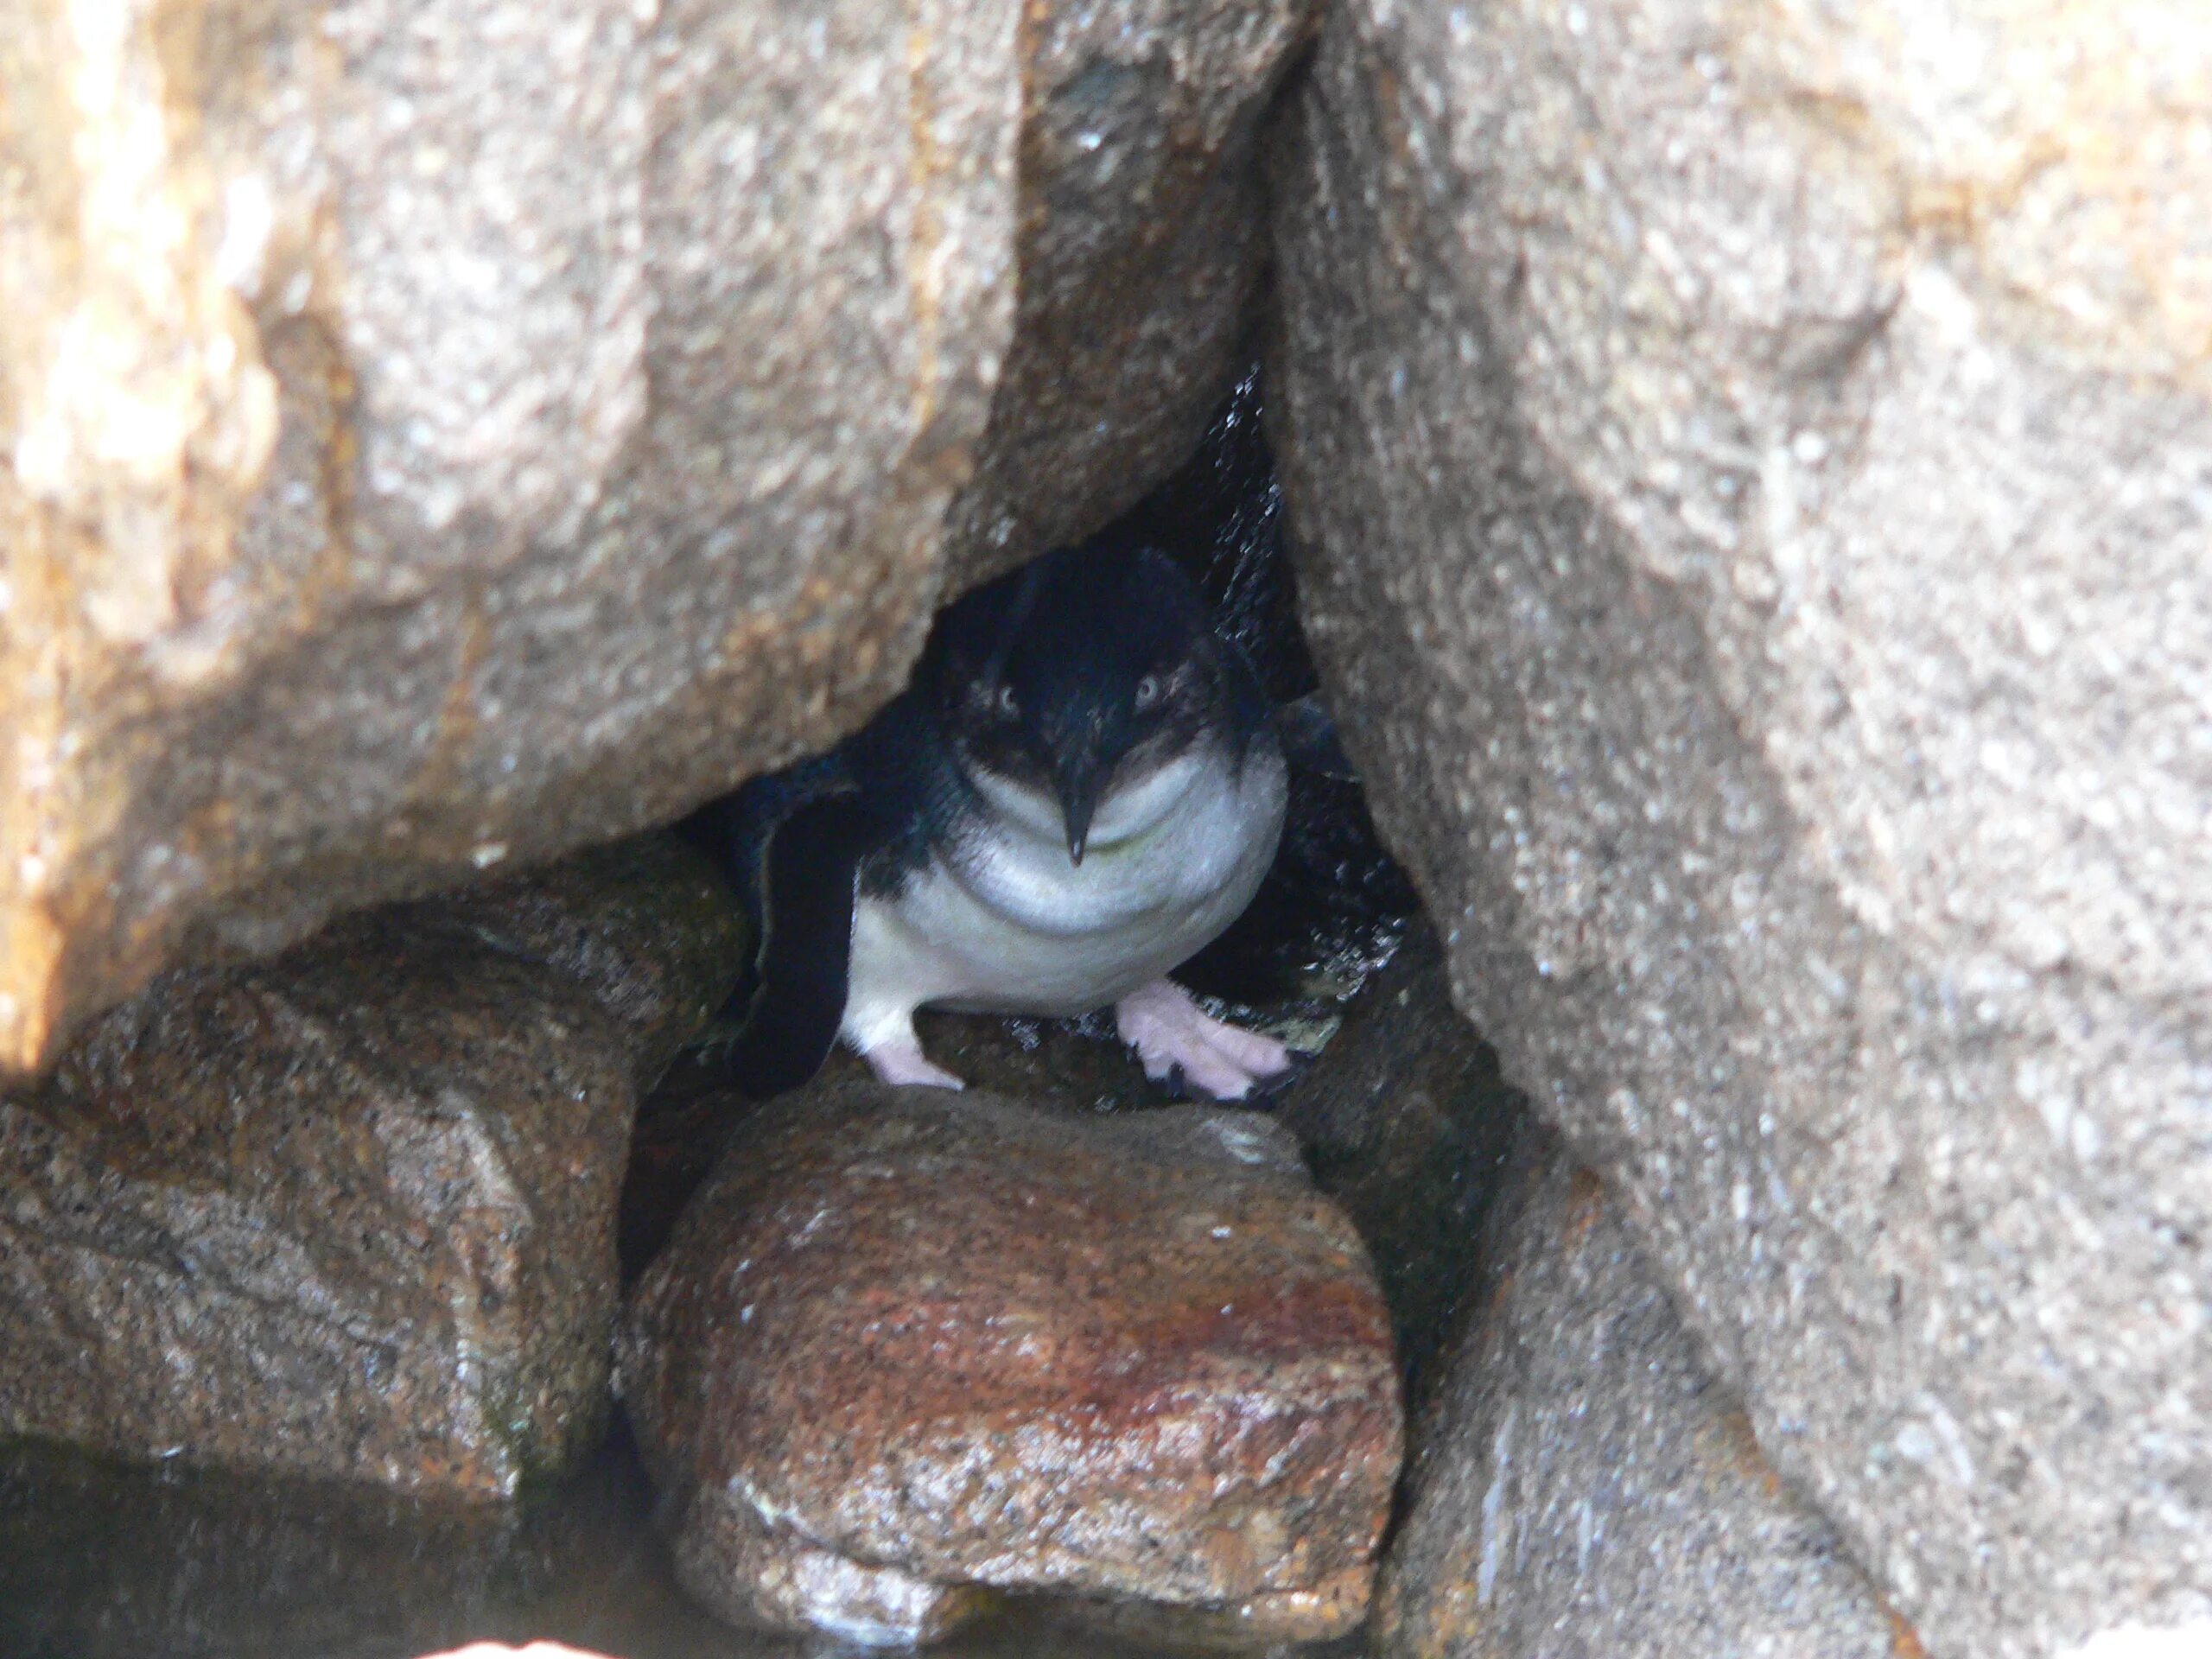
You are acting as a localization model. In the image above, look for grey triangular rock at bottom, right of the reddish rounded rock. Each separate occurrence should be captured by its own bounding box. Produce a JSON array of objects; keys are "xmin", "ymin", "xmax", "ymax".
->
[{"xmin": 1380, "ymin": 1128, "xmax": 1918, "ymax": 1659}]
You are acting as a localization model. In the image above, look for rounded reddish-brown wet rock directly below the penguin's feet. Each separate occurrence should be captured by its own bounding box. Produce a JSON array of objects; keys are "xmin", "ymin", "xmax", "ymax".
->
[{"xmin": 620, "ymin": 1082, "xmax": 1400, "ymax": 1639}]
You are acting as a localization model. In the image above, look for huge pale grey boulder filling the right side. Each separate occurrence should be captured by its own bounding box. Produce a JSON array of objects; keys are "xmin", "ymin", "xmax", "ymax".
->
[{"xmin": 1272, "ymin": 0, "xmax": 2212, "ymax": 1659}]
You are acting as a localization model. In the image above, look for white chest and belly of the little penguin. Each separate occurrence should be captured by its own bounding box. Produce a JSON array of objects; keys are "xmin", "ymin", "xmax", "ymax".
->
[{"xmin": 845, "ymin": 743, "xmax": 1285, "ymax": 1051}]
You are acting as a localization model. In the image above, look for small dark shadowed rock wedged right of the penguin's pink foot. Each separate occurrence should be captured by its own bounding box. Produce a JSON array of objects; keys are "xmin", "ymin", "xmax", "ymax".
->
[{"xmin": 1276, "ymin": 925, "xmax": 1529, "ymax": 1398}]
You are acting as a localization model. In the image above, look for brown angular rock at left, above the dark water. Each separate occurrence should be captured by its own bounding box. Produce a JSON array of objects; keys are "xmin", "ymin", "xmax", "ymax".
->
[{"xmin": 0, "ymin": 838, "xmax": 746, "ymax": 1496}]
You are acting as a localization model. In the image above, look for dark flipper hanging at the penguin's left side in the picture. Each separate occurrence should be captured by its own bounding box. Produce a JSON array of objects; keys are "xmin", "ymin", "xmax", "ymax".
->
[{"xmin": 730, "ymin": 787, "xmax": 889, "ymax": 1097}]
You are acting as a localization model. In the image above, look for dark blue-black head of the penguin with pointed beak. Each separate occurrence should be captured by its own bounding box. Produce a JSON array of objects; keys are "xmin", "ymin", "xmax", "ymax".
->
[{"xmin": 931, "ymin": 533, "xmax": 1249, "ymax": 865}]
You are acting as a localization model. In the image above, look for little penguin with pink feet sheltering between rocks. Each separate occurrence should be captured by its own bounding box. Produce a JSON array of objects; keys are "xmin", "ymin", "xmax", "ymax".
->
[{"xmin": 695, "ymin": 533, "xmax": 1289, "ymax": 1099}]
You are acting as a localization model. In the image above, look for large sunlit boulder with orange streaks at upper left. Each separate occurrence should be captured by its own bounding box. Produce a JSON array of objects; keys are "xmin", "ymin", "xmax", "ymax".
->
[{"xmin": 0, "ymin": 0, "xmax": 1310, "ymax": 1071}]
